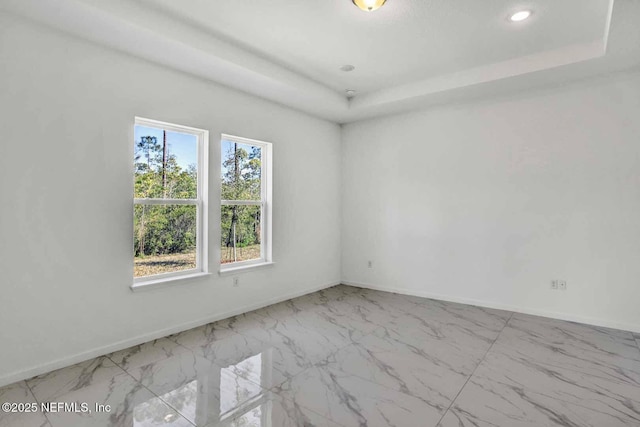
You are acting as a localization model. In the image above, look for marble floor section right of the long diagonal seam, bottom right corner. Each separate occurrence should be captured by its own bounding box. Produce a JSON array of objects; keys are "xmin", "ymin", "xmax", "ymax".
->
[{"xmin": 441, "ymin": 314, "xmax": 640, "ymax": 427}]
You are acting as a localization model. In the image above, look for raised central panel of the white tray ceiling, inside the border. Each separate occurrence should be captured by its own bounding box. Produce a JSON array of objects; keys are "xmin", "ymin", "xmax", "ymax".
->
[{"xmin": 138, "ymin": 0, "xmax": 609, "ymax": 93}]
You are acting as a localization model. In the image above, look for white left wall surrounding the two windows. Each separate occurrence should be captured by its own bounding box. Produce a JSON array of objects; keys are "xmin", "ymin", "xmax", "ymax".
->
[{"xmin": 0, "ymin": 15, "xmax": 340, "ymax": 385}]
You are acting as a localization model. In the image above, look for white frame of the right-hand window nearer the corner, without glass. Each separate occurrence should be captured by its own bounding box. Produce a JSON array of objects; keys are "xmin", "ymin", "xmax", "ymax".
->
[{"xmin": 219, "ymin": 134, "xmax": 273, "ymax": 273}]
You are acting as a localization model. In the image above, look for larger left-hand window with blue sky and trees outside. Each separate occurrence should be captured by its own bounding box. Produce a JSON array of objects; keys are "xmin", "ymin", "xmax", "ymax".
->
[{"xmin": 133, "ymin": 118, "xmax": 208, "ymax": 287}]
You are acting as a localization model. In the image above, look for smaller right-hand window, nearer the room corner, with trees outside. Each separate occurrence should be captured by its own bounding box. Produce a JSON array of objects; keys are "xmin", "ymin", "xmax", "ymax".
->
[{"xmin": 220, "ymin": 135, "xmax": 271, "ymax": 270}]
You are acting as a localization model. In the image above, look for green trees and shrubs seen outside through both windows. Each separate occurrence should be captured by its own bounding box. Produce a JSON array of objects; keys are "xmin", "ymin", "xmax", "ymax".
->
[{"xmin": 134, "ymin": 136, "xmax": 262, "ymax": 268}]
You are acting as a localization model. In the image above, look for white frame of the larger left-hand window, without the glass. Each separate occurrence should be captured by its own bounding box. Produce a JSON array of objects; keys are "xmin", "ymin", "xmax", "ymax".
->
[{"xmin": 132, "ymin": 117, "xmax": 209, "ymax": 289}]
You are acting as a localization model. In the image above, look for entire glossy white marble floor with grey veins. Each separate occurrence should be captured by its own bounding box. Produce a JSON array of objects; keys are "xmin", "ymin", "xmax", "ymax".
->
[{"xmin": 0, "ymin": 286, "xmax": 640, "ymax": 427}]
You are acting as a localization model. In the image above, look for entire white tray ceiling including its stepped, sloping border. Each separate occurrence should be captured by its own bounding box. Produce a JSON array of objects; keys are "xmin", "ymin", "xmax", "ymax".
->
[{"xmin": 0, "ymin": 0, "xmax": 640, "ymax": 123}]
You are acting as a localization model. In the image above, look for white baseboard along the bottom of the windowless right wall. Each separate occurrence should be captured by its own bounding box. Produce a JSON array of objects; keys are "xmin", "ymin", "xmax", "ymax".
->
[{"xmin": 342, "ymin": 280, "xmax": 640, "ymax": 333}]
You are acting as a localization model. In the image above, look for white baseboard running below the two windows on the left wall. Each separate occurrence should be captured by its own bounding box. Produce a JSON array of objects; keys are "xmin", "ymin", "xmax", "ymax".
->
[{"xmin": 0, "ymin": 281, "xmax": 341, "ymax": 387}]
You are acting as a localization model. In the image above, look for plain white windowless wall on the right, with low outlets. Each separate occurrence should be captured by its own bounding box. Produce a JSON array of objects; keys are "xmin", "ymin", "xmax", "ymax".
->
[{"xmin": 342, "ymin": 73, "xmax": 640, "ymax": 331}]
